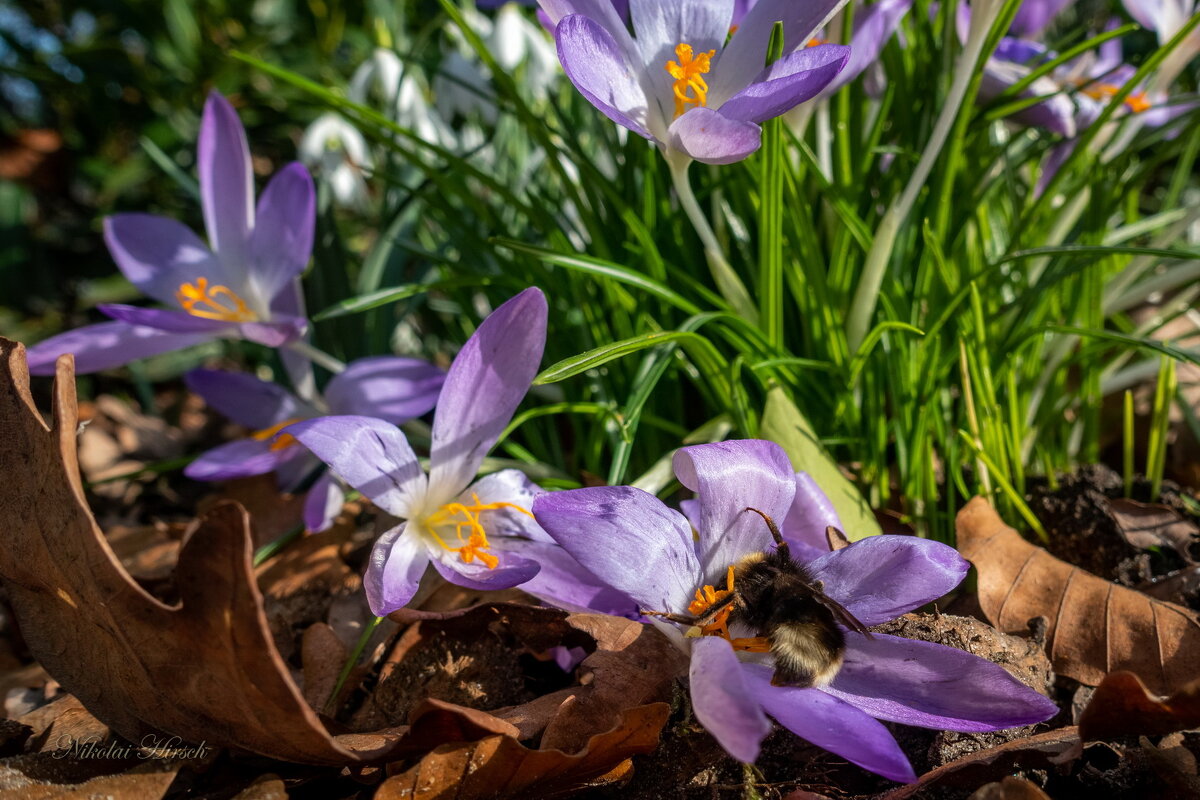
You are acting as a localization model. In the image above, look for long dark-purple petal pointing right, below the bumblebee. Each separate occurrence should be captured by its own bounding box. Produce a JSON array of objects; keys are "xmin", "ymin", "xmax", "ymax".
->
[{"xmin": 826, "ymin": 633, "xmax": 1058, "ymax": 733}]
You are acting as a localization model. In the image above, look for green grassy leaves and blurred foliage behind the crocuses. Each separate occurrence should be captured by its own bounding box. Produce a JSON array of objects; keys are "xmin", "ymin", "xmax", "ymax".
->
[{"xmin": 0, "ymin": 0, "xmax": 1200, "ymax": 539}]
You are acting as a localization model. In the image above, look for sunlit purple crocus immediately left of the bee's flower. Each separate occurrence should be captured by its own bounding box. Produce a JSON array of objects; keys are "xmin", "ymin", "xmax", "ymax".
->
[{"xmin": 284, "ymin": 288, "xmax": 568, "ymax": 616}]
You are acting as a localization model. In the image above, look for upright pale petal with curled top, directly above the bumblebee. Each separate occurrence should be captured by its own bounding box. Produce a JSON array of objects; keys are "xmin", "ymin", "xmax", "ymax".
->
[{"xmin": 674, "ymin": 439, "xmax": 796, "ymax": 585}]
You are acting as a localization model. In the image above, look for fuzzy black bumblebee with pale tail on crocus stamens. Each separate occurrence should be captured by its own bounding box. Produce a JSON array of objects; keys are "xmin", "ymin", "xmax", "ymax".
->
[{"xmin": 642, "ymin": 509, "xmax": 870, "ymax": 687}]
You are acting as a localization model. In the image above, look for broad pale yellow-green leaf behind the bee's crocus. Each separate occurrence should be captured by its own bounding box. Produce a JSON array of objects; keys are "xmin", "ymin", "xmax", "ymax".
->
[{"xmin": 758, "ymin": 387, "xmax": 883, "ymax": 541}]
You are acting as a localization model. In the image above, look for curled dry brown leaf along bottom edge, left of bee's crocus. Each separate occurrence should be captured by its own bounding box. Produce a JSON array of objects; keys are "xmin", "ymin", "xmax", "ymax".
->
[{"xmin": 374, "ymin": 703, "xmax": 671, "ymax": 800}]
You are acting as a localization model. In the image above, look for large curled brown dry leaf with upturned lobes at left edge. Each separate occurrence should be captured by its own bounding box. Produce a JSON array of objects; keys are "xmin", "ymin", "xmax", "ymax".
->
[{"xmin": 0, "ymin": 339, "xmax": 392, "ymax": 765}]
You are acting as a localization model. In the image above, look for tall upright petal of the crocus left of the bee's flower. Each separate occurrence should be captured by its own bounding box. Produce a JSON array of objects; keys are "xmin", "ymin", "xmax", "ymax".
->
[{"xmin": 430, "ymin": 288, "xmax": 547, "ymax": 505}]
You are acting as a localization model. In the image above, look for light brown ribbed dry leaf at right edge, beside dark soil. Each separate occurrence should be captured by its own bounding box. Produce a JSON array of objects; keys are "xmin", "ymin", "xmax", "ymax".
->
[{"xmin": 956, "ymin": 498, "xmax": 1200, "ymax": 694}]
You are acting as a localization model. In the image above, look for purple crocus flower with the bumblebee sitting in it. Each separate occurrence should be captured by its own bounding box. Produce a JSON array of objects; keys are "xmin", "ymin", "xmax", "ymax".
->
[{"xmin": 534, "ymin": 440, "xmax": 1057, "ymax": 781}]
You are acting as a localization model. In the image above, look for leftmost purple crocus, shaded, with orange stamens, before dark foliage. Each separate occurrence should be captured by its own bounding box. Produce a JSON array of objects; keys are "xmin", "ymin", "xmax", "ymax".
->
[{"xmin": 29, "ymin": 91, "xmax": 316, "ymax": 374}]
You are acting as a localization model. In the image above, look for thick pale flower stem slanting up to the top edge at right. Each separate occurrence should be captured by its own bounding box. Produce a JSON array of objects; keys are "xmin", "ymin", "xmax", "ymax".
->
[{"xmin": 846, "ymin": 2, "xmax": 1001, "ymax": 353}]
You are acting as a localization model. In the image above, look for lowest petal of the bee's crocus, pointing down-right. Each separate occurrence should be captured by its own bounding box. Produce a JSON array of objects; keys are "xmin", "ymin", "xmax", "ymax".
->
[{"xmin": 742, "ymin": 663, "xmax": 917, "ymax": 783}]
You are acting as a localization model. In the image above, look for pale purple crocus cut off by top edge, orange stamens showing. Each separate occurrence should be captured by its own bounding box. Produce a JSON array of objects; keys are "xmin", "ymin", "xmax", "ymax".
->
[{"xmin": 541, "ymin": 0, "xmax": 850, "ymax": 164}]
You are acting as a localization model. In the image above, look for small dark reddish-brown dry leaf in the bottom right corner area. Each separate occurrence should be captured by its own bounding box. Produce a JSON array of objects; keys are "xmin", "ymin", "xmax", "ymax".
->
[{"xmin": 1079, "ymin": 663, "xmax": 1200, "ymax": 741}]
